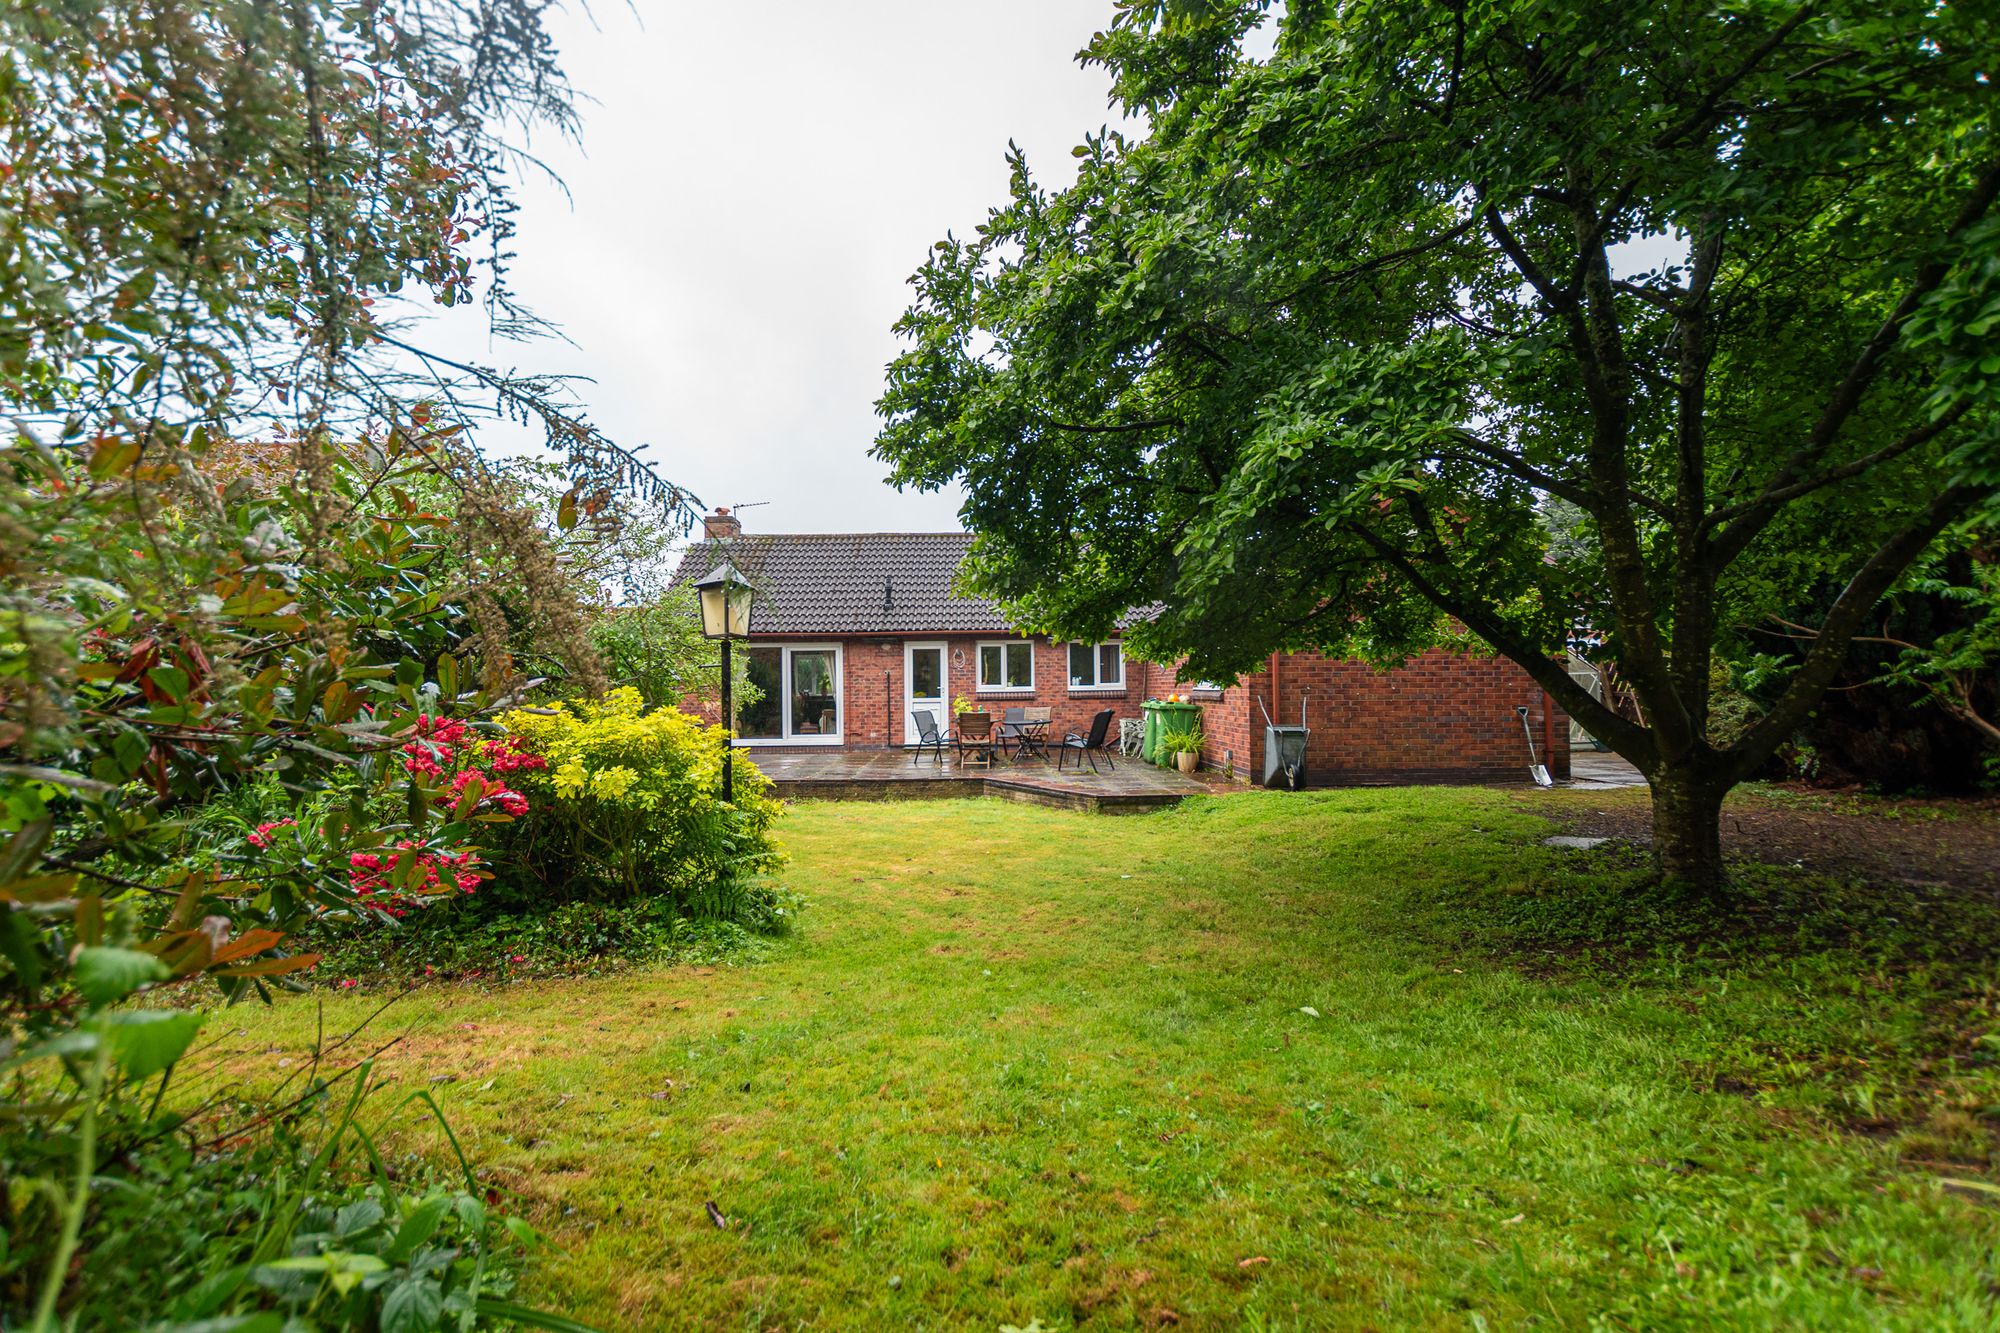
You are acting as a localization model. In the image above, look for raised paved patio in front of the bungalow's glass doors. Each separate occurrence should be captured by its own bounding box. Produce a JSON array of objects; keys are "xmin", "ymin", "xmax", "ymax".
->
[{"xmin": 744, "ymin": 749, "xmax": 1208, "ymax": 815}]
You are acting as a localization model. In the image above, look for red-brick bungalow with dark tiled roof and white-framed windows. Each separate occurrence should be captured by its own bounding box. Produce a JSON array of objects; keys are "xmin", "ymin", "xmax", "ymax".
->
[{"xmin": 674, "ymin": 508, "xmax": 1570, "ymax": 787}]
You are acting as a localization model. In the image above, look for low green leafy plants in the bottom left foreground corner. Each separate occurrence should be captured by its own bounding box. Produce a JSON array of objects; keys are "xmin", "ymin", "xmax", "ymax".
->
[{"xmin": 0, "ymin": 1063, "xmax": 578, "ymax": 1333}]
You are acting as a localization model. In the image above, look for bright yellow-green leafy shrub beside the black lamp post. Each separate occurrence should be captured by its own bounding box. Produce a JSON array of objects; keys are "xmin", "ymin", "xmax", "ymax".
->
[{"xmin": 500, "ymin": 689, "xmax": 780, "ymax": 919}]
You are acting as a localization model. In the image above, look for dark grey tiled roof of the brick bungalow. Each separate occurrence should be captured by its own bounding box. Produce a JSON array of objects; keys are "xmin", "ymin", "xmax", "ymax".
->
[{"xmin": 674, "ymin": 532, "xmax": 1008, "ymax": 636}]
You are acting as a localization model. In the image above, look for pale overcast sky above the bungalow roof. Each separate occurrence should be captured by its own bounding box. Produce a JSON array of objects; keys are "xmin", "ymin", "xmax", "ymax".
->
[{"xmin": 426, "ymin": 0, "xmax": 1184, "ymax": 532}]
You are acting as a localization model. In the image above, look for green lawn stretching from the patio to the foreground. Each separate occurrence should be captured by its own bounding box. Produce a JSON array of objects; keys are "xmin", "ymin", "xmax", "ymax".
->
[{"xmin": 195, "ymin": 789, "xmax": 2000, "ymax": 1329}]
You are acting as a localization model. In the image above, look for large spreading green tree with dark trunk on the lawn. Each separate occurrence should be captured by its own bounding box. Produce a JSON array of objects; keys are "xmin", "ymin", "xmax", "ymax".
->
[{"xmin": 878, "ymin": 0, "xmax": 2000, "ymax": 889}]
